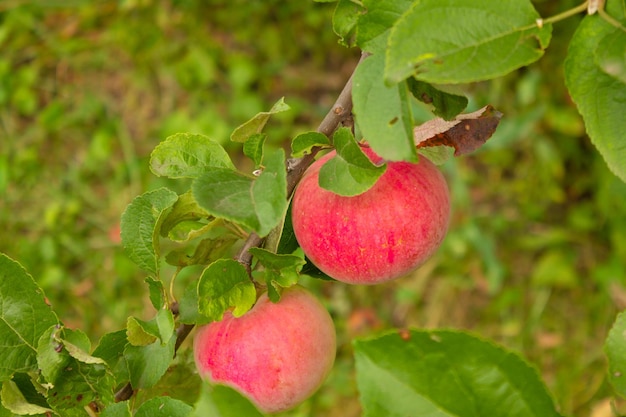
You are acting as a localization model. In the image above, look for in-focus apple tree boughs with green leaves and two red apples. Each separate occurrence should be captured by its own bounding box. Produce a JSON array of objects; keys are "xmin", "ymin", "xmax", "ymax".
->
[{"xmin": 0, "ymin": 0, "xmax": 626, "ymax": 417}]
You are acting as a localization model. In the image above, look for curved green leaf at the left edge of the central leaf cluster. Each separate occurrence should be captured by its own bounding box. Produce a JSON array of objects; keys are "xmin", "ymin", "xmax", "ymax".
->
[{"xmin": 121, "ymin": 188, "xmax": 178, "ymax": 276}]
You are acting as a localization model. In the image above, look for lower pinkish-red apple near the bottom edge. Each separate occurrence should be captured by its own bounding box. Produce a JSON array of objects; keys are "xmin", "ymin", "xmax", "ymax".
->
[{"xmin": 194, "ymin": 286, "xmax": 337, "ymax": 413}]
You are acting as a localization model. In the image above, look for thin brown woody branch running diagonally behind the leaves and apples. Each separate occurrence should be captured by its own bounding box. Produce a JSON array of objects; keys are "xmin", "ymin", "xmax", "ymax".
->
[{"xmin": 115, "ymin": 54, "xmax": 367, "ymax": 402}]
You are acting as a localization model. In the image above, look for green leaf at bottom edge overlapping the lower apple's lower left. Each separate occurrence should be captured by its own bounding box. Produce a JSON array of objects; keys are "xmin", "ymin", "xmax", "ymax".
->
[{"xmin": 193, "ymin": 382, "xmax": 263, "ymax": 417}]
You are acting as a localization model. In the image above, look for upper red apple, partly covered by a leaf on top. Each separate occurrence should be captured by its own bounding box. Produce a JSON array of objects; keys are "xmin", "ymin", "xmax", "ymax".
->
[{"xmin": 292, "ymin": 147, "xmax": 450, "ymax": 285}]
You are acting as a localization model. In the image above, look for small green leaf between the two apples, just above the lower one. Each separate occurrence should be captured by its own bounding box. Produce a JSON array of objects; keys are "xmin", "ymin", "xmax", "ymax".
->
[{"xmin": 249, "ymin": 248, "xmax": 306, "ymax": 303}]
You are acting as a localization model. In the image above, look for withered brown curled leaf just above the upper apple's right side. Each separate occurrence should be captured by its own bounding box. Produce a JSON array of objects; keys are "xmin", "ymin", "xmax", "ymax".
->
[{"xmin": 413, "ymin": 106, "xmax": 502, "ymax": 156}]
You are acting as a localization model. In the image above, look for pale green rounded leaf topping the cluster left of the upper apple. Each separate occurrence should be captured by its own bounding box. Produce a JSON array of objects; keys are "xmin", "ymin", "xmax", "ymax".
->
[{"xmin": 150, "ymin": 133, "xmax": 234, "ymax": 178}]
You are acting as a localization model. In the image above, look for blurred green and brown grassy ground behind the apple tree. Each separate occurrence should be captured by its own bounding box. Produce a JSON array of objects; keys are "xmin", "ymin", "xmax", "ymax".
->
[{"xmin": 0, "ymin": 0, "xmax": 626, "ymax": 417}]
